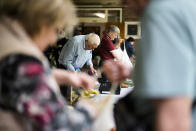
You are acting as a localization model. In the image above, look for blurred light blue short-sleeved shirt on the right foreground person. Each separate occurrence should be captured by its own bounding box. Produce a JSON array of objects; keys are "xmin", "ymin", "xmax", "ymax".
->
[{"xmin": 135, "ymin": 0, "xmax": 196, "ymax": 131}]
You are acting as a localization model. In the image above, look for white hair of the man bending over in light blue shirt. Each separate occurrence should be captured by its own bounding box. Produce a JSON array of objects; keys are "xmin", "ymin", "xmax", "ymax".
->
[{"xmin": 85, "ymin": 33, "xmax": 100, "ymax": 46}]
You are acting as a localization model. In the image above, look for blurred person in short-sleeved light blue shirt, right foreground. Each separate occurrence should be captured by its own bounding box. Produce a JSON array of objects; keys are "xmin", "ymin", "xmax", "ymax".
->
[{"xmin": 104, "ymin": 0, "xmax": 196, "ymax": 131}]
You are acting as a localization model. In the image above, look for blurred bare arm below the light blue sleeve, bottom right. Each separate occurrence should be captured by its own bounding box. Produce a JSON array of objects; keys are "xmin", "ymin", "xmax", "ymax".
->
[{"xmin": 155, "ymin": 97, "xmax": 192, "ymax": 131}]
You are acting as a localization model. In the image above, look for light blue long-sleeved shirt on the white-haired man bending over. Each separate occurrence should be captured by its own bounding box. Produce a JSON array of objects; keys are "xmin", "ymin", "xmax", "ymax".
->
[{"xmin": 58, "ymin": 35, "xmax": 92, "ymax": 71}]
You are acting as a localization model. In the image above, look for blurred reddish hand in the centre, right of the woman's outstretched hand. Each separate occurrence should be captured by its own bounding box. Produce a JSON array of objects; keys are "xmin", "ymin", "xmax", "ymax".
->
[{"xmin": 103, "ymin": 60, "xmax": 132, "ymax": 82}]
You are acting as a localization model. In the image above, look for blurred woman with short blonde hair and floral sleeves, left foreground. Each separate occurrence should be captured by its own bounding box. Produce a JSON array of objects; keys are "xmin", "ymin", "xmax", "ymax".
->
[{"xmin": 0, "ymin": 0, "xmax": 100, "ymax": 131}]
